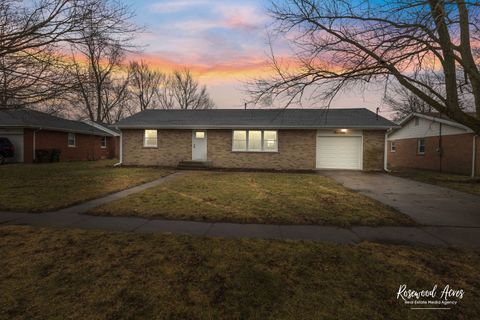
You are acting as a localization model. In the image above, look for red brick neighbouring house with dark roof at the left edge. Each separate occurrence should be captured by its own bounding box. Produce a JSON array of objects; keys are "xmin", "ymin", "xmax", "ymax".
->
[{"xmin": 0, "ymin": 109, "xmax": 120, "ymax": 163}]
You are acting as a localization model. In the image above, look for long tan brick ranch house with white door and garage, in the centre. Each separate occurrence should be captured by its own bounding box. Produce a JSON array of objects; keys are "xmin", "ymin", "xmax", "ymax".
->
[{"xmin": 117, "ymin": 109, "xmax": 396, "ymax": 171}]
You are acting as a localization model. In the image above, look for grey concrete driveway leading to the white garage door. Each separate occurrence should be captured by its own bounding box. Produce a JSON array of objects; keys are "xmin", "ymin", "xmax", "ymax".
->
[{"xmin": 322, "ymin": 171, "xmax": 480, "ymax": 228}]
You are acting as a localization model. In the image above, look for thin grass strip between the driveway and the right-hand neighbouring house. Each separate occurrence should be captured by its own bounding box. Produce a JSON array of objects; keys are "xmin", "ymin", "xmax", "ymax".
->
[{"xmin": 392, "ymin": 169, "xmax": 480, "ymax": 195}]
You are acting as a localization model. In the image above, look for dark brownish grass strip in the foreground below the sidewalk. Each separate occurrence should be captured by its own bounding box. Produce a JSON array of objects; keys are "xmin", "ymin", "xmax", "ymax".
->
[{"xmin": 0, "ymin": 227, "xmax": 480, "ymax": 320}]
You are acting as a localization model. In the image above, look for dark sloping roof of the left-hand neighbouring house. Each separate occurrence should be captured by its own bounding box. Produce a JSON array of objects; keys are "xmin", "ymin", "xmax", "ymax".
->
[{"xmin": 0, "ymin": 109, "xmax": 112, "ymax": 136}]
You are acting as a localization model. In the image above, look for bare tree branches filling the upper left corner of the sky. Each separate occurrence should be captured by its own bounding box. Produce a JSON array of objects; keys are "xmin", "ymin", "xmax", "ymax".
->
[{"xmin": 0, "ymin": 0, "xmax": 85, "ymax": 108}]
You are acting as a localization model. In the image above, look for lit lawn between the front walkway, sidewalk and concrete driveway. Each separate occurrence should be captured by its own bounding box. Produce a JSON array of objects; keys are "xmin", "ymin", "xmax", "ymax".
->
[{"xmin": 90, "ymin": 172, "xmax": 413, "ymax": 226}]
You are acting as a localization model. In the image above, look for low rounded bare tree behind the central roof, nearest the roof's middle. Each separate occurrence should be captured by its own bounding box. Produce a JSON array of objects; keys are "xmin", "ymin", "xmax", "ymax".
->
[{"xmin": 159, "ymin": 69, "xmax": 215, "ymax": 109}]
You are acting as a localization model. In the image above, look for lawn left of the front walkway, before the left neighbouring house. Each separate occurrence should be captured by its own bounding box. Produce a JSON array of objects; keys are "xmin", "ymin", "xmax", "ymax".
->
[{"xmin": 0, "ymin": 160, "xmax": 172, "ymax": 212}]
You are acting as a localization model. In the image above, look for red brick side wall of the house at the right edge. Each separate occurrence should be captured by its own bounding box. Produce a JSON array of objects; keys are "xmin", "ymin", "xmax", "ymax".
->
[{"xmin": 388, "ymin": 134, "xmax": 480, "ymax": 174}]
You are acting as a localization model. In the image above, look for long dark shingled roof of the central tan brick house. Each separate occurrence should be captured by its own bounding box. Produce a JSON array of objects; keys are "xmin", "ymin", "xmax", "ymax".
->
[{"xmin": 117, "ymin": 109, "xmax": 397, "ymax": 129}]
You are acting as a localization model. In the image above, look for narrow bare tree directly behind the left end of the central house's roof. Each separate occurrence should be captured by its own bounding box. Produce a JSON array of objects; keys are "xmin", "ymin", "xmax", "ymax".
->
[{"xmin": 129, "ymin": 61, "xmax": 166, "ymax": 111}]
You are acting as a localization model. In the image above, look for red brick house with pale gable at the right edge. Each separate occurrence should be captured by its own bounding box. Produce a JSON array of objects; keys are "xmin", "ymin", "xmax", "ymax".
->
[{"xmin": 387, "ymin": 113, "xmax": 480, "ymax": 176}]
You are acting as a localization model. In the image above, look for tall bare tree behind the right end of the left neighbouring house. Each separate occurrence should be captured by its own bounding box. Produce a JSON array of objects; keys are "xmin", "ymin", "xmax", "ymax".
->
[{"xmin": 66, "ymin": 0, "xmax": 139, "ymax": 122}]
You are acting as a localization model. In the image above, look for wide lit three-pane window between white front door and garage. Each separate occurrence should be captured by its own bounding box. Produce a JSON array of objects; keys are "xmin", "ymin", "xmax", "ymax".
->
[{"xmin": 232, "ymin": 130, "xmax": 278, "ymax": 152}]
